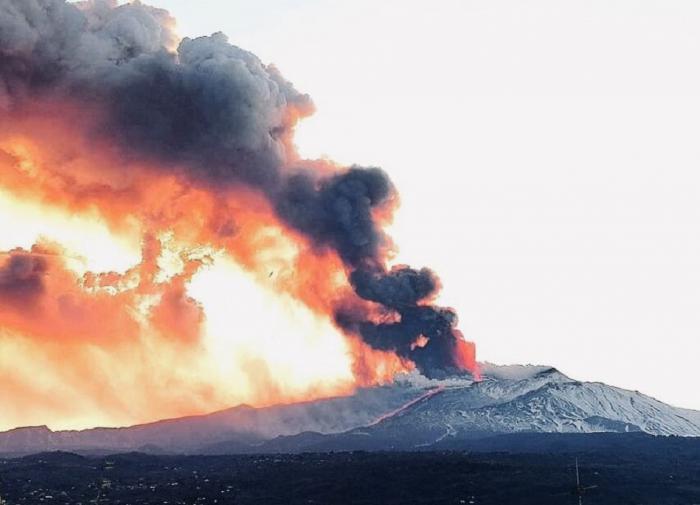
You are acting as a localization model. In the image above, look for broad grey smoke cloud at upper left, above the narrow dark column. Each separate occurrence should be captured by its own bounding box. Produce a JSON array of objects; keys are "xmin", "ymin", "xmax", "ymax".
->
[{"xmin": 0, "ymin": 0, "xmax": 313, "ymax": 189}]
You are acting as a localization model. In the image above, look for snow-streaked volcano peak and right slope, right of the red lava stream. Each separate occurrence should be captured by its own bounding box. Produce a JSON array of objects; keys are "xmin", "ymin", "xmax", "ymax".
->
[{"xmin": 351, "ymin": 366, "xmax": 700, "ymax": 446}]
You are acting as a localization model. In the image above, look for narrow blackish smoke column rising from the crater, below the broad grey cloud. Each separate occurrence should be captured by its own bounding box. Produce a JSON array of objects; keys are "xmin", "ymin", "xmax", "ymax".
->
[{"xmin": 277, "ymin": 167, "xmax": 470, "ymax": 376}]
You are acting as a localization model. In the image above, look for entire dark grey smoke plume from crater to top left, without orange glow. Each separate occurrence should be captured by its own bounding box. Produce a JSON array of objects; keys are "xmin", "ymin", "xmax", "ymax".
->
[{"xmin": 0, "ymin": 0, "xmax": 475, "ymax": 375}]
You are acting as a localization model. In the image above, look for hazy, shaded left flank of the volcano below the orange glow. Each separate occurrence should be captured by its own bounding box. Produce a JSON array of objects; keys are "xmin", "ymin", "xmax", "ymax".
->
[{"xmin": 0, "ymin": 385, "xmax": 426, "ymax": 453}]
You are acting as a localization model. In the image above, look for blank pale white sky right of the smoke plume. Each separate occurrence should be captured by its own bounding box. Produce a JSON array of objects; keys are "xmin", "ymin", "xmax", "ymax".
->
[{"xmin": 148, "ymin": 0, "xmax": 700, "ymax": 409}]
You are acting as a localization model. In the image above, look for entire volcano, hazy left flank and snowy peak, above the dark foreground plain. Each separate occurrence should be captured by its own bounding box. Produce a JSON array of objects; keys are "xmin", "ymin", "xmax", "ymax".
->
[{"xmin": 0, "ymin": 364, "xmax": 700, "ymax": 453}]
